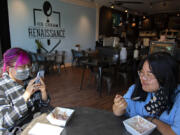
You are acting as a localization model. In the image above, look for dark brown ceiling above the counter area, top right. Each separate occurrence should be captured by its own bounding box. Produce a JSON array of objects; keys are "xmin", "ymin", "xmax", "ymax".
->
[{"xmin": 83, "ymin": 0, "xmax": 180, "ymax": 15}]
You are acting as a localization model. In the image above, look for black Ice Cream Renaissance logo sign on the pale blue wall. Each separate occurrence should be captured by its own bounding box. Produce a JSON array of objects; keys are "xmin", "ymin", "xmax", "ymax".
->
[{"xmin": 28, "ymin": 1, "xmax": 65, "ymax": 53}]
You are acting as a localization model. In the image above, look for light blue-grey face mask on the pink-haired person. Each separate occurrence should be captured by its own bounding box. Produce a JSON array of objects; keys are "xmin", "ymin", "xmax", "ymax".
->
[{"xmin": 15, "ymin": 68, "xmax": 30, "ymax": 80}]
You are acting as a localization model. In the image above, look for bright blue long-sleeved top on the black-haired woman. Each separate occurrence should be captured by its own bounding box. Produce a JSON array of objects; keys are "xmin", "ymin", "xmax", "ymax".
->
[{"xmin": 124, "ymin": 85, "xmax": 180, "ymax": 135}]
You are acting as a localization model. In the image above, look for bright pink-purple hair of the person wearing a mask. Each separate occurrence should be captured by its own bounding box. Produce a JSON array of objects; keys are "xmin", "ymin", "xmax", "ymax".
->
[{"xmin": 3, "ymin": 48, "xmax": 31, "ymax": 72}]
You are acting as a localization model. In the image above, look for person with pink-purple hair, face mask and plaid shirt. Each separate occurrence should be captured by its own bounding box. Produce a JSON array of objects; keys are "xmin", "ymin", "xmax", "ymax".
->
[{"xmin": 0, "ymin": 48, "xmax": 49, "ymax": 135}]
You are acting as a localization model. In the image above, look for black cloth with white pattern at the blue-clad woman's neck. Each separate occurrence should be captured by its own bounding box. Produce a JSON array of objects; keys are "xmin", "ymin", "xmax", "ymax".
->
[{"xmin": 145, "ymin": 88, "xmax": 168, "ymax": 116}]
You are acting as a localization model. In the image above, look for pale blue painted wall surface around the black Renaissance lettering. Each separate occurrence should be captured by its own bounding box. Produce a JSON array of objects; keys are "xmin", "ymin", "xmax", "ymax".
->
[{"xmin": 8, "ymin": 0, "xmax": 96, "ymax": 62}]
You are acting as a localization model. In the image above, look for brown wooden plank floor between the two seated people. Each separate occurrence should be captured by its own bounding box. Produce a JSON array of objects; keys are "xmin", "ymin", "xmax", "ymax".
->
[{"xmin": 45, "ymin": 67, "xmax": 133, "ymax": 111}]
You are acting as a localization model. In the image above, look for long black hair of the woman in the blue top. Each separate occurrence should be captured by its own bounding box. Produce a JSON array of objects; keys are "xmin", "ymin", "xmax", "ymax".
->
[{"xmin": 131, "ymin": 52, "xmax": 178, "ymax": 111}]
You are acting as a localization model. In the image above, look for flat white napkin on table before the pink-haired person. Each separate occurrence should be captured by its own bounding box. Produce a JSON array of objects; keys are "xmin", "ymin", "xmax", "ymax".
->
[{"xmin": 28, "ymin": 123, "xmax": 63, "ymax": 135}]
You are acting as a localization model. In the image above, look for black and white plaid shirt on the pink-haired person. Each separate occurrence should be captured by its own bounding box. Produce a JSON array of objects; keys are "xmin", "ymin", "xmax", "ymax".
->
[{"xmin": 0, "ymin": 73, "xmax": 49, "ymax": 134}]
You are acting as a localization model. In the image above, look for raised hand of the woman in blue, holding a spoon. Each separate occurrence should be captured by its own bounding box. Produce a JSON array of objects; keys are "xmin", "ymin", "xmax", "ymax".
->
[{"xmin": 113, "ymin": 94, "xmax": 127, "ymax": 116}]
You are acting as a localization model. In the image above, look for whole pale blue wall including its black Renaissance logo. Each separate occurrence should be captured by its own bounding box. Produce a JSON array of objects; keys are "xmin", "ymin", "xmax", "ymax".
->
[{"xmin": 8, "ymin": 0, "xmax": 96, "ymax": 64}]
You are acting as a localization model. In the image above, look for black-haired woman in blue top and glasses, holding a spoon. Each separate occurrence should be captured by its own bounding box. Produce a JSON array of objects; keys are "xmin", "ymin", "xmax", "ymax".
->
[{"xmin": 113, "ymin": 52, "xmax": 180, "ymax": 135}]
